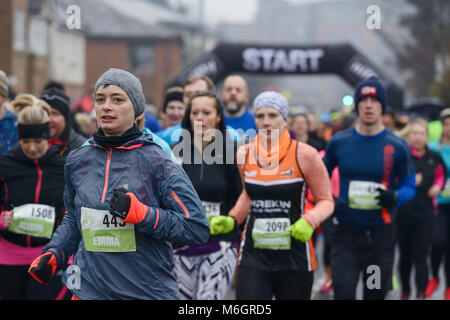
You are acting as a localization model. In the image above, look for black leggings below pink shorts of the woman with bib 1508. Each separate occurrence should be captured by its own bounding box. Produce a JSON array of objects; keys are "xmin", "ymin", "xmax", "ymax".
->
[{"xmin": 0, "ymin": 265, "xmax": 71, "ymax": 300}]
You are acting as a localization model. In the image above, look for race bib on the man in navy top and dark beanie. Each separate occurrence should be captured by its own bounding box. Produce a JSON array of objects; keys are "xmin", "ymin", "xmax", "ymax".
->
[{"xmin": 348, "ymin": 181, "xmax": 386, "ymax": 210}]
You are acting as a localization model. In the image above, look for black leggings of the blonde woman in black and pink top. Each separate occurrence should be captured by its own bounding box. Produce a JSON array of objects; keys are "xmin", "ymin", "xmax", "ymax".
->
[{"xmin": 397, "ymin": 211, "xmax": 434, "ymax": 296}]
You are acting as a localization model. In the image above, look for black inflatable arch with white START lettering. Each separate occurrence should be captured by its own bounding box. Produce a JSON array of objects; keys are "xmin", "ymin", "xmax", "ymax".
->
[{"xmin": 167, "ymin": 43, "xmax": 403, "ymax": 110}]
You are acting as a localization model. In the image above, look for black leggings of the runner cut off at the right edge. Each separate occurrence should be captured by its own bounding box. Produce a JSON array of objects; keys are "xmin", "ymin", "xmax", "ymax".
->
[{"xmin": 431, "ymin": 204, "xmax": 450, "ymax": 288}]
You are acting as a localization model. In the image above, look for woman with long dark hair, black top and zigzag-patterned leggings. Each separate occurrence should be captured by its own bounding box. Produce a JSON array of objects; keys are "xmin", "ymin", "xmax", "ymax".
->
[{"xmin": 173, "ymin": 91, "xmax": 242, "ymax": 300}]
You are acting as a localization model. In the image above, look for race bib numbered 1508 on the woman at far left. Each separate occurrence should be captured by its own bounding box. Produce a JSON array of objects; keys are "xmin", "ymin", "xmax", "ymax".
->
[{"xmin": 8, "ymin": 203, "xmax": 55, "ymax": 239}]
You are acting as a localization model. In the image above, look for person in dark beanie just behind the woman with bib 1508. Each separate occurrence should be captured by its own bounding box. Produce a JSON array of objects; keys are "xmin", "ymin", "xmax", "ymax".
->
[{"xmin": 40, "ymin": 87, "xmax": 86, "ymax": 154}]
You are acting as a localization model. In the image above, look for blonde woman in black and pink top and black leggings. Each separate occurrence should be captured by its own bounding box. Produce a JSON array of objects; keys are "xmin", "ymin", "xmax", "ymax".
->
[{"xmin": 397, "ymin": 119, "xmax": 445, "ymax": 300}]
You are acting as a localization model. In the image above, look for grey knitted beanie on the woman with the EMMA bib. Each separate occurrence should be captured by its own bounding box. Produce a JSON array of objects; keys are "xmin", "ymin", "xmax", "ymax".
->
[{"xmin": 94, "ymin": 68, "xmax": 145, "ymax": 119}]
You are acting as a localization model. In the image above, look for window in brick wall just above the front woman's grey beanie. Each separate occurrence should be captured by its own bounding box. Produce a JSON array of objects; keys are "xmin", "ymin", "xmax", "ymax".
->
[{"xmin": 130, "ymin": 44, "xmax": 155, "ymax": 76}]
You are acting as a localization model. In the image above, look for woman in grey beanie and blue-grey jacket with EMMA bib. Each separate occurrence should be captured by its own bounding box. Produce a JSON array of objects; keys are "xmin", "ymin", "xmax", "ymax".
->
[{"xmin": 29, "ymin": 69, "xmax": 209, "ymax": 300}]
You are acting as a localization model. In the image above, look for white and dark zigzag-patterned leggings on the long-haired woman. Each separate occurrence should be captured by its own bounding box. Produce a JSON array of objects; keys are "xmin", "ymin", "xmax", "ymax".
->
[{"xmin": 172, "ymin": 248, "xmax": 237, "ymax": 300}]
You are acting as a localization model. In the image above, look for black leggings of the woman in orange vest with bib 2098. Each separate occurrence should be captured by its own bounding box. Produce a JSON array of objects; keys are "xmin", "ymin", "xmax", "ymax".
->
[{"xmin": 236, "ymin": 266, "xmax": 314, "ymax": 300}]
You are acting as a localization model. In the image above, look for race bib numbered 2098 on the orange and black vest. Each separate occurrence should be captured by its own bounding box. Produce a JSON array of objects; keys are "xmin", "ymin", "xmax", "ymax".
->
[{"xmin": 252, "ymin": 218, "xmax": 291, "ymax": 250}]
